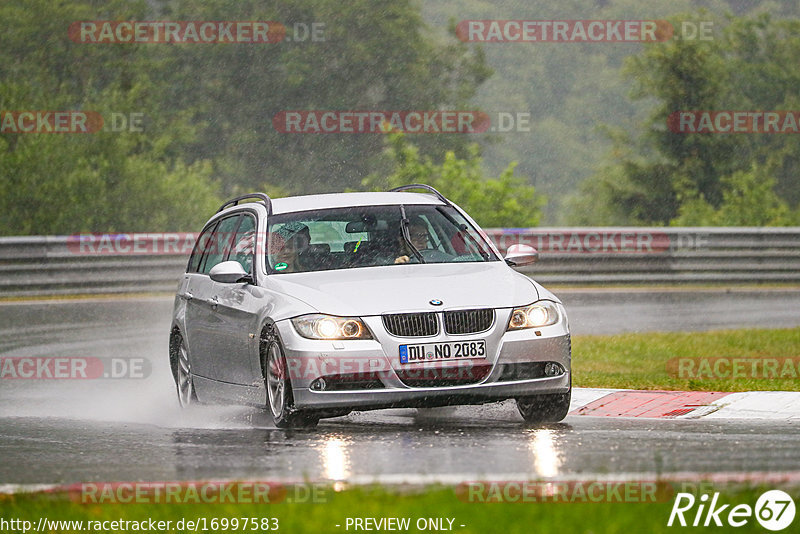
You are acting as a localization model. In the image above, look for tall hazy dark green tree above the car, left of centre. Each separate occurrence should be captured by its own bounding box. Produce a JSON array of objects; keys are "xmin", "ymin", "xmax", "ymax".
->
[{"xmin": 157, "ymin": 0, "xmax": 490, "ymax": 197}]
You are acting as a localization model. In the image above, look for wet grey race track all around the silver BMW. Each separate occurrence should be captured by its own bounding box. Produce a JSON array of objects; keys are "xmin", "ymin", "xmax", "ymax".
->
[{"xmin": 0, "ymin": 290, "xmax": 800, "ymax": 485}]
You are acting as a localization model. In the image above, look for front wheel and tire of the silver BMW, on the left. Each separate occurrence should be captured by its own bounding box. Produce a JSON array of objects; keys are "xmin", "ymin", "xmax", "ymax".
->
[{"xmin": 261, "ymin": 327, "xmax": 319, "ymax": 428}]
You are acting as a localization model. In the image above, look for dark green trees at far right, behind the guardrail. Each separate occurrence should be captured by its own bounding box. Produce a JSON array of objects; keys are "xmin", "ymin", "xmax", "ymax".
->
[{"xmin": 573, "ymin": 12, "xmax": 800, "ymax": 225}]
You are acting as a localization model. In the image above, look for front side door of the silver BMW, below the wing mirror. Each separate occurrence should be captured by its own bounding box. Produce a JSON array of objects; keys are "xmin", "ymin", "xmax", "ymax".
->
[{"xmin": 212, "ymin": 213, "xmax": 261, "ymax": 385}]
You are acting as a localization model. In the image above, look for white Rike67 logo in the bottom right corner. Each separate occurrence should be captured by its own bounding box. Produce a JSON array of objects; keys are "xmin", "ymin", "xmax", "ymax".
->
[{"xmin": 667, "ymin": 490, "xmax": 795, "ymax": 531}]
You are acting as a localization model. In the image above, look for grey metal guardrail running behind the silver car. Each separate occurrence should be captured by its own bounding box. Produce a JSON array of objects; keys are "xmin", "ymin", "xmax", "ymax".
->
[{"xmin": 0, "ymin": 227, "xmax": 800, "ymax": 297}]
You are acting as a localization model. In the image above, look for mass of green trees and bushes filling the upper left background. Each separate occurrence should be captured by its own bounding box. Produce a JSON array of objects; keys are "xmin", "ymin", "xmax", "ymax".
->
[{"xmin": 0, "ymin": 0, "xmax": 490, "ymax": 235}]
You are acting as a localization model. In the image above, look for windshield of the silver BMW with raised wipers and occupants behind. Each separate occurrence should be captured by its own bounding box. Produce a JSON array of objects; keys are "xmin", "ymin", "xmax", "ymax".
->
[{"xmin": 267, "ymin": 205, "xmax": 499, "ymax": 273}]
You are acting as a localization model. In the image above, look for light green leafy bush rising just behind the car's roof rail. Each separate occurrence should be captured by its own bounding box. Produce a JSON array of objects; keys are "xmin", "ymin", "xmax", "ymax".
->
[{"xmin": 362, "ymin": 133, "xmax": 545, "ymax": 228}]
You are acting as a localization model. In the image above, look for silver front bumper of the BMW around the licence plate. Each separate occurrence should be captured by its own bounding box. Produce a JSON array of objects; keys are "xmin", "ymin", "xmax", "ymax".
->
[{"xmin": 277, "ymin": 318, "xmax": 572, "ymax": 409}]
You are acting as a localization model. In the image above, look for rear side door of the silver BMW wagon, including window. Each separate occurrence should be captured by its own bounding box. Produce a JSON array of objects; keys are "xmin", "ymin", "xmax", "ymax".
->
[{"xmin": 186, "ymin": 214, "xmax": 241, "ymax": 380}]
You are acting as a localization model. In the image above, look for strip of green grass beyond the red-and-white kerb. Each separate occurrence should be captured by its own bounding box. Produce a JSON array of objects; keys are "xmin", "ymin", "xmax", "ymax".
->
[{"xmin": 572, "ymin": 328, "xmax": 800, "ymax": 391}]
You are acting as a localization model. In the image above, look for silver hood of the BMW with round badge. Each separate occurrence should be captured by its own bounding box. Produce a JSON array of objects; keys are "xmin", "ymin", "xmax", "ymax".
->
[{"xmin": 268, "ymin": 261, "xmax": 539, "ymax": 316}]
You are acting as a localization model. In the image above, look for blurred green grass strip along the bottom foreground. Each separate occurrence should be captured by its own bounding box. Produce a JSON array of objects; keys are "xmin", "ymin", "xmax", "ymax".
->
[{"xmin": 0, "ymin": 485, "xmax": 800, "ymax": 534}]
